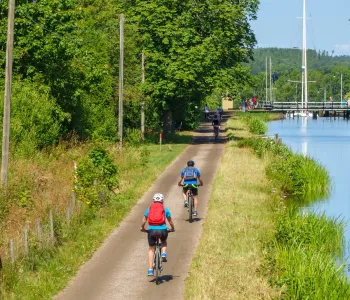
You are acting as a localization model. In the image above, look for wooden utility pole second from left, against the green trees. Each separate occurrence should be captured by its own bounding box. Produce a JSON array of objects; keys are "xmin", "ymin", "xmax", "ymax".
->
[{"xmin": 118, "ymin": 14, "xmax": 124, "ymax": 149}]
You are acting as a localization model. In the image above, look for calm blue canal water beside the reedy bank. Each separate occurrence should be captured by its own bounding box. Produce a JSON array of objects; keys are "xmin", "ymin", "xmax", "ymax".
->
[{"xmin": 268, "ymin": 118, "xmax": 350, "ymax": 255}]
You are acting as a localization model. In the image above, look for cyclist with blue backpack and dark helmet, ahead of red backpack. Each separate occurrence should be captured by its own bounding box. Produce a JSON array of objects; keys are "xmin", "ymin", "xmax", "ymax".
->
[{"xmin": 178, "ymin": 160, "xmax": 203, "ymax": 216}]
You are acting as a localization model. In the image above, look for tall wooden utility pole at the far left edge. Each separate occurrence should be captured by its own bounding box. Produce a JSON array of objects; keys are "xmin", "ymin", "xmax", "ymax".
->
[{"xmin": 1, "ymin": 0, "xmax": 15, "ymax": 193}]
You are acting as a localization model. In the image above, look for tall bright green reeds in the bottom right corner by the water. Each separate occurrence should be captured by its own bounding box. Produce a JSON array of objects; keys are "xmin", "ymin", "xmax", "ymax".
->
[{"xmin": 264, "ymin": 207, "xmax": 350, "ymax": 299}]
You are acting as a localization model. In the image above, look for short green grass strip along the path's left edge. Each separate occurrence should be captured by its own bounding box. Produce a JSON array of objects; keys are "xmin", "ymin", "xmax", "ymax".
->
[{"xmin": 1, "ymin": 141, "xmax": 187, "ymax": 299}]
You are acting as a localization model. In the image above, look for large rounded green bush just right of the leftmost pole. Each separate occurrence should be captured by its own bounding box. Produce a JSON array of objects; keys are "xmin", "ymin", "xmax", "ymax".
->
[{"xmin": 0, "ymin": 79, "xmax": 66, "ymax": 155}]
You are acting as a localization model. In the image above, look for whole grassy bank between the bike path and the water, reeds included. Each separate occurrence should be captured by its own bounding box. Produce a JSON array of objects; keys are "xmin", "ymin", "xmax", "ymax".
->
[{"xmin": 186, "ymin": 115, "xmax": 350, "ymax": 299}]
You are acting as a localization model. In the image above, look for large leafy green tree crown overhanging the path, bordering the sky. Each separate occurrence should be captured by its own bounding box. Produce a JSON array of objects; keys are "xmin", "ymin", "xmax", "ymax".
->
[{"xmin": 125, "ymin": 0, "xmax": 257, "ymax": 128}]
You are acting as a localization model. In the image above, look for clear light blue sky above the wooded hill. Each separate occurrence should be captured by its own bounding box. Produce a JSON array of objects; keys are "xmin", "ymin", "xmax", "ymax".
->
[{"xmin": 252, "ymin": 0, "xmax": 350, "ymax": 55}]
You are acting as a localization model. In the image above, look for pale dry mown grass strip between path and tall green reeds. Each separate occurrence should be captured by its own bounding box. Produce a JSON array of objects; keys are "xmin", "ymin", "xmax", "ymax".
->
[{"xmin": 186, "ymin": 119, "xmax": 278, "ymax": 299}]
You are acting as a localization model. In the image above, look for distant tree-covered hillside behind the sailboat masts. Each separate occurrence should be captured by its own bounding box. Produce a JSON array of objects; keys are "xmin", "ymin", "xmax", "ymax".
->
[{"xmin": 242, "ymin": 48, "xmax": 350, "ymax": 101}]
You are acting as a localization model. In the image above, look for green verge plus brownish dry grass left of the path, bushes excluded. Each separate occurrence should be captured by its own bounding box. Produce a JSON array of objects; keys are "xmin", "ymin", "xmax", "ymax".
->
[{"xmin": 0, "ymin": 143, "xmax": 187, "ymax": 299}]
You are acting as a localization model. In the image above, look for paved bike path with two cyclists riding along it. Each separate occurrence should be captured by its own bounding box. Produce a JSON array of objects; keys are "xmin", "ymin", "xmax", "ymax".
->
[{"xmin": 56, "ymin": 115, "xmax": 224, "ymax": 300}]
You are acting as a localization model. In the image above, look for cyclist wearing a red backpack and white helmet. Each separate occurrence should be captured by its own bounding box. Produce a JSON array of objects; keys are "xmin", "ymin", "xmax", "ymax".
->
[{"xmin": 141, "ymin": 194, "xmax": 175, "ymax": 276}]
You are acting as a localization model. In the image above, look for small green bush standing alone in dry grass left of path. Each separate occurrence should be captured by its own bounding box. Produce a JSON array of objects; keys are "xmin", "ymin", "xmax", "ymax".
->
[{"xmin": 76, "ymin": 147, "xmax": 118, "ymax": 208}]
